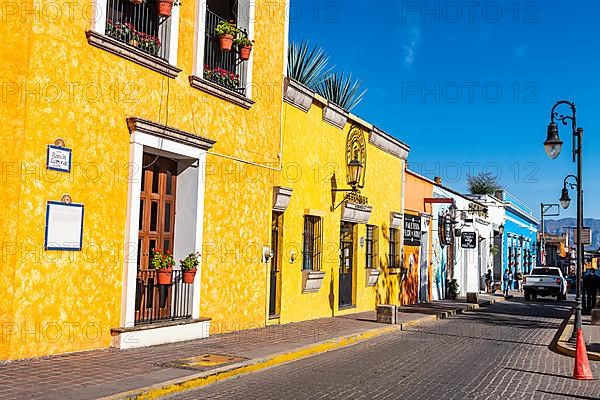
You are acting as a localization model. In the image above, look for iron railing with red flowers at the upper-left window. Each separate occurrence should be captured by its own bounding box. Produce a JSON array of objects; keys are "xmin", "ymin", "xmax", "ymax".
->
[{"xmin": 106, "ymin": 0, "xmax": 170, "ymax": 60}]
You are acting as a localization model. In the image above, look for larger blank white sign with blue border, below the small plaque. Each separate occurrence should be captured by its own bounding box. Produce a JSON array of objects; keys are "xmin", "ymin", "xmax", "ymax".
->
[{"xmin": 44, "ymin": 201, "xmax": 83, "ymax": 251}]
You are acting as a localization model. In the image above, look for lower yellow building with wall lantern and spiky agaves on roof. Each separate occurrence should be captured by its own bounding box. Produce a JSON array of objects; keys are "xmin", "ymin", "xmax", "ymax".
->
[{"xmin": 269, "ymin": 80, "xmax": 409, "ymax": 323}]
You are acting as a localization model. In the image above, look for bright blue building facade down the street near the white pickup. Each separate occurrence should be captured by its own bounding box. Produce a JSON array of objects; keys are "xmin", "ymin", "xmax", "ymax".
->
[{"xmin": 494, "ymin": 190, "xmax": 539, "ymax": 283}]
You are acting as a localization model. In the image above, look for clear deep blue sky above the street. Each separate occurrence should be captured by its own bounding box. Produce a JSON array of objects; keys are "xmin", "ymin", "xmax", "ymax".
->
[{"xmin": 290, "ymin": 0, "xmax": 600, "ymax": 218}]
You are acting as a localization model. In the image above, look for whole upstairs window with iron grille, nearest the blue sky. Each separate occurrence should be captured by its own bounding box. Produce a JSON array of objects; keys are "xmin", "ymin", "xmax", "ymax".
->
[{"xmin": 203, "ymin": 0, "xmax": 251, "ymax": 96}]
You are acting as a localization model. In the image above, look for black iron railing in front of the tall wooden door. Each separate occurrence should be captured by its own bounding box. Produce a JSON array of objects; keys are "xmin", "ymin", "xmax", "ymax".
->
[{"xmin": 135, "ymin": 270, "xmax": 194, "ymax": 325}]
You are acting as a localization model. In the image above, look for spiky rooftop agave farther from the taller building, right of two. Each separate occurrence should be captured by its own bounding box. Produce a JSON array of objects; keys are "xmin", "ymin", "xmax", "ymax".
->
[{"xmin": 316, "ymin": 72, "xmax": 367, "ymax": 111}]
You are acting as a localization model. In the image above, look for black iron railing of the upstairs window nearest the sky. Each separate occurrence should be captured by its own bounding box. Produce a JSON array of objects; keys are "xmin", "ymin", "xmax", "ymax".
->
[{"xmin": 204, "ymin": 8, "xmax": 248, "ymax": 96}]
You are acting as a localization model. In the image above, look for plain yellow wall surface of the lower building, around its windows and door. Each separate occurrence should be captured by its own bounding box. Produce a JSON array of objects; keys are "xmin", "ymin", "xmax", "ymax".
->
[{"xmin": 281, "ymin": 97, "xmax": 404, "ymax": 323}]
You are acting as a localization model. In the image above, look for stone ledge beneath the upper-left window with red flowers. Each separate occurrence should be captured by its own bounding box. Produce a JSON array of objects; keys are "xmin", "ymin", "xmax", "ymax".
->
[{"xmin": 85, "ymin": 31, "xmax": 181, "ymax": 78}]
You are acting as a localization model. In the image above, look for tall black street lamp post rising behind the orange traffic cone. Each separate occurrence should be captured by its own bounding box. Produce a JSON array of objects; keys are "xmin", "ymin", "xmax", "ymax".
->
[{"xmin": 544, "ymin": 100, "xmax": 583, "ymax": 340}]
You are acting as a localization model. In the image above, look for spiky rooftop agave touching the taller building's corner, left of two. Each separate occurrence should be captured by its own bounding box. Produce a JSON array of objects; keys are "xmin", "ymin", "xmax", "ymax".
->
[{"xmin": 287, "ymin": 41, "xmax": 332, "ymax": 90}]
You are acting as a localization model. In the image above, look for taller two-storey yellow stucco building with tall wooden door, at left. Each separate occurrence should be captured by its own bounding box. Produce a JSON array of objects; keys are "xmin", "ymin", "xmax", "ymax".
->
[{"xmin": 0, "ymin": 0, "xmax": 288, "ymax": 359}]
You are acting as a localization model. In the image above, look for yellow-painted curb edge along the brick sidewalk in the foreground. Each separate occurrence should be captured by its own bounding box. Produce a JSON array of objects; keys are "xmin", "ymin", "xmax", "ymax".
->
[{"xmin": 101, "ymin": 325, "xmax": 401, "ymax": 400}]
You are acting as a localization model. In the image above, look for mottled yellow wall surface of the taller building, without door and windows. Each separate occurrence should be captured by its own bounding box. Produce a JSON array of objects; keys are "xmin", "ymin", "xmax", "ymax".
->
[{"xmin": 0, "ymin": 1, "xmax": 285, "ymax": 359}]
